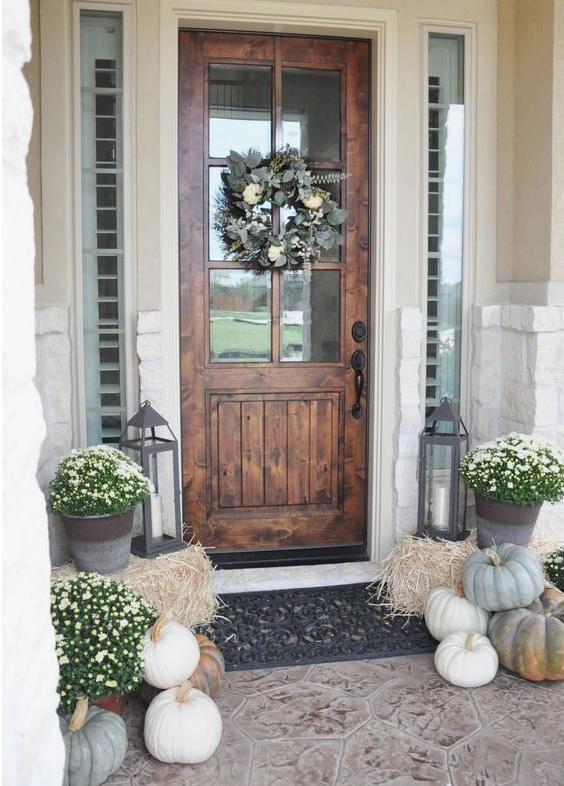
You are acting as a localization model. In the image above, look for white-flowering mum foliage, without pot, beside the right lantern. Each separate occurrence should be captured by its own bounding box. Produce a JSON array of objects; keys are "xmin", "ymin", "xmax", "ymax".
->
[{"xmin": 460, "ymin": 433, "xmax": 564, "ymax": 505}]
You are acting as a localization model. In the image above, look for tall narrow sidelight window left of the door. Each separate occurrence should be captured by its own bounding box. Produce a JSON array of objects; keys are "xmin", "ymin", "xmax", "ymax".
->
[{"xmin": 80, "ymin": 11, "xmax": 126, "ymax": 445}]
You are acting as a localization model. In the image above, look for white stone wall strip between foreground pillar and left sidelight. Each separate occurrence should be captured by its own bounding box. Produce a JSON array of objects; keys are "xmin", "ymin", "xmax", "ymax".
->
[{"xmin": 35, "ymin": 306, "xmax": 73, "ymax": 565}]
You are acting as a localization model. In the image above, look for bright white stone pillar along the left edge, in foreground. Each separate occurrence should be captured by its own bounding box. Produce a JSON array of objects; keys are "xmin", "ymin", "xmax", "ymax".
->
[{"xmin": 2, "ymin": 0, "xmax": 64, "ymax": 786}]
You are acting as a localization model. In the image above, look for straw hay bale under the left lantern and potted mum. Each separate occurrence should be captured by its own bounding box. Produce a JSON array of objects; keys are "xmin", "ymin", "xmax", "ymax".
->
[{"xmin": 51, "ymin": 544, "xmax": 219, "ymax": 628}]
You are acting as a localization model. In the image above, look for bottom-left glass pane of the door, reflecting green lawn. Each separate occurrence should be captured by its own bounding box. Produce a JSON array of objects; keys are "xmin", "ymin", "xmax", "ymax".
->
[{"xmin": 209, "ymin": 269, "xmax": 272, "ymax": 363}]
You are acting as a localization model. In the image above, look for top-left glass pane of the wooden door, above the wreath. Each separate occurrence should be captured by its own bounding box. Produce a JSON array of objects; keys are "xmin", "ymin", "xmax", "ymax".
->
[{"xmin": 209, "ymin": 63, "xmax": 272, "ymax": 158}]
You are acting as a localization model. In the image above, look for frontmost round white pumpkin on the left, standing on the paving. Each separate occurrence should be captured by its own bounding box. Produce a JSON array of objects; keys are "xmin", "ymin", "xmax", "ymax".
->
[{"xmin": 145, "ymin": 681, "xmax": 222, "ymax": 764}]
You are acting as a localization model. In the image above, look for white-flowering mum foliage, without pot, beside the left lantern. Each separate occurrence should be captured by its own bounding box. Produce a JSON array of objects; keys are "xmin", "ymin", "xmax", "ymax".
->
[{"xmin": 49, "ymin": 445, "xmax": 151, "ymax": 516}]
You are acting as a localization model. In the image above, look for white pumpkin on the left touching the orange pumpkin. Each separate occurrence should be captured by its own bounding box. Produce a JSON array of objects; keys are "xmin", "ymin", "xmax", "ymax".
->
[{"xmin": 143, "ymin": 614, "xmax": 200, "ymax": 690}]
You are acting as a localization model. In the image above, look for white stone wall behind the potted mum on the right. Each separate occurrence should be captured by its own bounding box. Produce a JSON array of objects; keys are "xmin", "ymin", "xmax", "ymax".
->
[{"xmin": 471, "ymin": 305, "xmax": 564, "ymax": 541}]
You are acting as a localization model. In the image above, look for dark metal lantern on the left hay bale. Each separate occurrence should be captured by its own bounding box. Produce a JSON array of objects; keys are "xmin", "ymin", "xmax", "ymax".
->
[{"xmin": 119, "ymin": 401, "xmax": 186, "ymax": 557}]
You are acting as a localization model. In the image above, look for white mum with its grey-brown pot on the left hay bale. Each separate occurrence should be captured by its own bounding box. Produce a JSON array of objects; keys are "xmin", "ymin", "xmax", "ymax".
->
[{"xmin": 49, "ymin": 445, "xmax": 151, "ymax": 573}]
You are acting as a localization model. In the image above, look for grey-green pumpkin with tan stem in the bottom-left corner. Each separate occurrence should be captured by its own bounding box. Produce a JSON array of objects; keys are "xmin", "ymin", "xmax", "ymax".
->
[{"xmin": 59, "ymin": 699, "xmax": 127, "ymax": 786}]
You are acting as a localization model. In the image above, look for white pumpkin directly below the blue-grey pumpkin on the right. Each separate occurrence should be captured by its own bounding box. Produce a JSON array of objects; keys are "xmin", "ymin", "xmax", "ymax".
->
[{"xmin": 425, "ymin": 587, "xmax": 490, "ymax": 641}]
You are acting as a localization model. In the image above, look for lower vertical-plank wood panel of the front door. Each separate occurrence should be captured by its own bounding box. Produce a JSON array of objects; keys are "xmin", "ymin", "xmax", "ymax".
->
[{"xmin": 209, "ymin": 393, "xmax": 341, "ymax": 514}]
